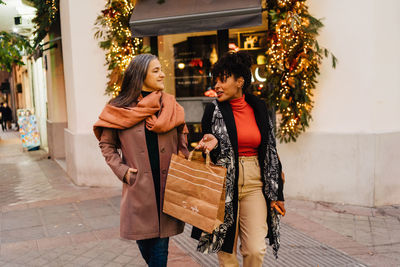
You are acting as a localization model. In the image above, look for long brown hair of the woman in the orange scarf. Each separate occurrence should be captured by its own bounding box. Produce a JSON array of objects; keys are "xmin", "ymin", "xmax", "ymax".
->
[{"xmin": 109, "ymin": 54, "xmax": 157, "ymax": 107}]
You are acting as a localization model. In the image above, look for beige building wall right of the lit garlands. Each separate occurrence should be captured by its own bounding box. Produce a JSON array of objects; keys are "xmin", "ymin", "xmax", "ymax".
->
[{"xmin": 279, "ymin": 0, "xmax": 400, "ymax": 206}]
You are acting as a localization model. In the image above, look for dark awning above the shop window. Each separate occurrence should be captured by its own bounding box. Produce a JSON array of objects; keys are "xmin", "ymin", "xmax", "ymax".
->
[{"xmin": 129, "ymin": 0, "xmax": 262, "ymax": 37}]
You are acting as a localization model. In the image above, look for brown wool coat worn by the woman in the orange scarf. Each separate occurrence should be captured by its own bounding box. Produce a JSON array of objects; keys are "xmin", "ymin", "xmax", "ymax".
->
[{"xmin": 99, "ymin": 121, "xmax": 189, "ymax": 240}]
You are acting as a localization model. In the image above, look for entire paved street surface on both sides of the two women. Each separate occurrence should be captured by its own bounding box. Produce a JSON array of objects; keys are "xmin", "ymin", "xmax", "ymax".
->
[{"xmin": 0, "ymin": 132, "xmax": 400, "ymax": 266}]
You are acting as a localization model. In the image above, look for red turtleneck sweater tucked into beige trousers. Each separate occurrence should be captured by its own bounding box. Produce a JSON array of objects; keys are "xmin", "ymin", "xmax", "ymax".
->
[{"xmin": 229, "ymin": 95, "xmax": 261, "ymax": 157}]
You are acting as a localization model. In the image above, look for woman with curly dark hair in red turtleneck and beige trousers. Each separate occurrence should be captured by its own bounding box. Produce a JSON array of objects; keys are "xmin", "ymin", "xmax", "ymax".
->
[{"xmin": 192, "ymin": 52, "xmax": 285, "ymax": 267}]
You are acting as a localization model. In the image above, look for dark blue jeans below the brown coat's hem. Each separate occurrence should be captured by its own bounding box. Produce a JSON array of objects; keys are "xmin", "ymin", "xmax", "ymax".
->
[{"xmin": 136, "ymin": 237, "xmax": 169, "ymax": 267}]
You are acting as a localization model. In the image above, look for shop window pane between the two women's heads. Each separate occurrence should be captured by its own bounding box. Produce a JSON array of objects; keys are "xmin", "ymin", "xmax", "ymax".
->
[{"xmin": 158, "ymin": 31, "xmax": 218, "ymax": 98}]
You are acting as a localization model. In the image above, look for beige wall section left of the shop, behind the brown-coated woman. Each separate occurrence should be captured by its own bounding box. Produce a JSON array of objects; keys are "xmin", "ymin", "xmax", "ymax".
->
[{"xmin": 60, "ymin": 0, "xmax": 120, "ymax": 186}]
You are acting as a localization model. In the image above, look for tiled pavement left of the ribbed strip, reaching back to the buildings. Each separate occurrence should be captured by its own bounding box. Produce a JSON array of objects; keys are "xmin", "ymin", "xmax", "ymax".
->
[{"xmin": 0, "ymin": 132, "xmax": 199, "ymax": 266}]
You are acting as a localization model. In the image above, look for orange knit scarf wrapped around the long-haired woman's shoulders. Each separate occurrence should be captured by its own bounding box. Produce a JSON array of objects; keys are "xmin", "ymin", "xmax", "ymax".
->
[{"xmin": 93, "ymin": 91, "xmax": 187, "ymax": 140}]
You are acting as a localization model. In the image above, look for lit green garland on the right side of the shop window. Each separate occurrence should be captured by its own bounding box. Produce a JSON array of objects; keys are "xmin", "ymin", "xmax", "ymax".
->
[{"xmin": 263, "ymin": 0, "xmax": 337, "ymax": 142}]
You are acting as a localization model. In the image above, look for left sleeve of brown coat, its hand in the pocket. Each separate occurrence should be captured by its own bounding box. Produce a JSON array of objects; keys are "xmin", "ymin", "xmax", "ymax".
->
[{"xmin": 99, "ymin": 128, "xmax": 129, "ymax": 183}]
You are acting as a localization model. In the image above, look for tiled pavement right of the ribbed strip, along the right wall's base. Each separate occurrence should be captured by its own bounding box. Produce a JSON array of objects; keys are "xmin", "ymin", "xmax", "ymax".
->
[{"xmin": 283, "ymin": 200, "xmax": 400, "ymax": 266}]
